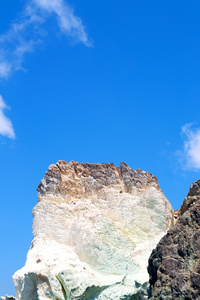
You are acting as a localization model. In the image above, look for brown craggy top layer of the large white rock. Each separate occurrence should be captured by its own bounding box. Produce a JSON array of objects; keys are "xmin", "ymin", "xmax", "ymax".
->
[{"xmin": 37, "ymin": 160, "xmax": 160, "ymax": 198}]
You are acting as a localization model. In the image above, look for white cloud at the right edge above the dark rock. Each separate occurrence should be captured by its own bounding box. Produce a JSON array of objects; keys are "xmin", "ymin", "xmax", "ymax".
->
[{"xmin": 181, "ymin": 123, "xmax": 200, "ymax": 170}]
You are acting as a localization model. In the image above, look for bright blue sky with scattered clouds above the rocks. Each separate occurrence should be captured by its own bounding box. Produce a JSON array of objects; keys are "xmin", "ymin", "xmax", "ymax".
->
[{"xmin": 0, "ymin": 0, "xmax": 200, "ymax": 295}]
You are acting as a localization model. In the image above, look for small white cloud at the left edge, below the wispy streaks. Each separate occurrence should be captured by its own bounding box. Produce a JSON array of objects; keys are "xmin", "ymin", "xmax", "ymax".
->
[{"xmin": 0, "ymin": 95, "xmax": 15, "ymax": 139}]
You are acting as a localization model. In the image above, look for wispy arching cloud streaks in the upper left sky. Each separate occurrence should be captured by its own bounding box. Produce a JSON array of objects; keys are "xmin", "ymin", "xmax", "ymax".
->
[{"xmin": 0, "ymin": 0, "xmax": 91, "ymax": 79}]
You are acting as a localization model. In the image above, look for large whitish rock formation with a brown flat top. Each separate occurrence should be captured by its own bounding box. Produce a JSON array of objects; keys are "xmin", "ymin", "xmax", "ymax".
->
[{"xmin": 13, "ymin": 161, "xmax": 174, "ymax": 300}]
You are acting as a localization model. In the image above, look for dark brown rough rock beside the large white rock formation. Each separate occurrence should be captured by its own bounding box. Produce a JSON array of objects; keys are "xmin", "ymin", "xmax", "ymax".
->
[{"xmin": 148, "ymin": 180, "xmax": 200, "ymax": 300}]
